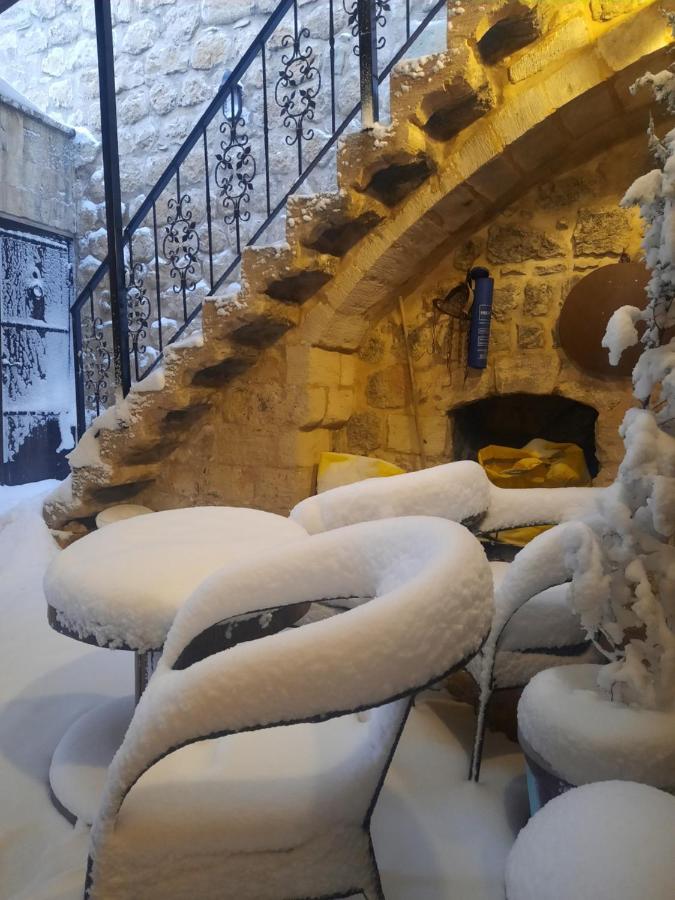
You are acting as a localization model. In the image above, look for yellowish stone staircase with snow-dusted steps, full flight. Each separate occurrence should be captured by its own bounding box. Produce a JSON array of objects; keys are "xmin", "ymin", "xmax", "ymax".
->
[{"xmin": 45, "ymin": 0, "xmax": 664, "ymax": 531}]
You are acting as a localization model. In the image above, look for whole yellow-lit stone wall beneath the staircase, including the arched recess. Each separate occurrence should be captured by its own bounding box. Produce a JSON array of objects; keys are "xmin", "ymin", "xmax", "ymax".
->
[{"xmin": 138, "ymin": 133, "xmax": 649, "ymax": 514}]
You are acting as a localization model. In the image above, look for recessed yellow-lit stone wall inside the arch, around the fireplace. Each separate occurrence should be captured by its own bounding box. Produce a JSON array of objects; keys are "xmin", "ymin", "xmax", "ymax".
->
[{"xmin": 333, "ymin": 135, "xmax": 650, "ymax": 483}]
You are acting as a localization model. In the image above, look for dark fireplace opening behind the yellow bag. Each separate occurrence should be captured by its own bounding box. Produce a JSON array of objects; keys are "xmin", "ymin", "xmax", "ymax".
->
[{"xmin": 448, "ymin": 394, "xmax": 600, "ymax": 478}]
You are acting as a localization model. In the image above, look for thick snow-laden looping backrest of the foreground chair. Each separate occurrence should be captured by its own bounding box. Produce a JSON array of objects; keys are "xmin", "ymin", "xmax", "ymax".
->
[{"xmin": 92, "ymin": 517, "xmax": 493, "ymax": 857}]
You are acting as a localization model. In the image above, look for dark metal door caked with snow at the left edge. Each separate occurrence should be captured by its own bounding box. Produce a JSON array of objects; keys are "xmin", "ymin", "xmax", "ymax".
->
[{"xmin": 0, "ymin": 219, "xmax": 75, "ymax": 484}]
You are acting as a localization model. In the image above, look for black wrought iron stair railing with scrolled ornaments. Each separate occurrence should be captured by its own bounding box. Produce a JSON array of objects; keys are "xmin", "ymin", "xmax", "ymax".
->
[{"xmin": 72, "ymin": 0, "xmax": 446, "ymax": 433}]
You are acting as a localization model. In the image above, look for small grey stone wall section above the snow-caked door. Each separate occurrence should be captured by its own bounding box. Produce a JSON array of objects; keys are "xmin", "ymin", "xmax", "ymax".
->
[{"xmin": 0, "ymin": 83, "xmax": 76, "ymax": 237}]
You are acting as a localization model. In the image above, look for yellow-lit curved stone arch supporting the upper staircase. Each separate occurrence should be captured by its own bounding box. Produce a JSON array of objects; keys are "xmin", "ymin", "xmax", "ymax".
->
[{"xmin": 298, "ymin": 0, "xmax": 672, "ymax": 352}]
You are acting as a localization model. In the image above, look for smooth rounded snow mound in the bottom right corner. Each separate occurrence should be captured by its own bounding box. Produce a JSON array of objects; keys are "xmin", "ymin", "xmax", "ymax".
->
[{"xmin": 506, "ymin": 781, "xmax": 675, "ymax": 900}]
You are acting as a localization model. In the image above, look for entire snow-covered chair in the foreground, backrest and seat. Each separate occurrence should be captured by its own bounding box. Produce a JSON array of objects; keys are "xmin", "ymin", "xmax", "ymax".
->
[{"xmin": 86, "ymin": 517, "xmax": 493, "ymax": 900}]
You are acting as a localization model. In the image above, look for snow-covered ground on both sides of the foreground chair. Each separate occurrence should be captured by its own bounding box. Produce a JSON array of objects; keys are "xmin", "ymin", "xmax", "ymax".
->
[{"xmin": 0, "ymin": 483, "xmax": 527, "ymax": 900}]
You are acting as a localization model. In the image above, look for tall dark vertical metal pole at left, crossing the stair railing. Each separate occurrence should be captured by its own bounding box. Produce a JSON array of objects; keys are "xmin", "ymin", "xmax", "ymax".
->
[{"xmin": 94, "ymin": 0, "xmax": 131, "ymax": 396}]
